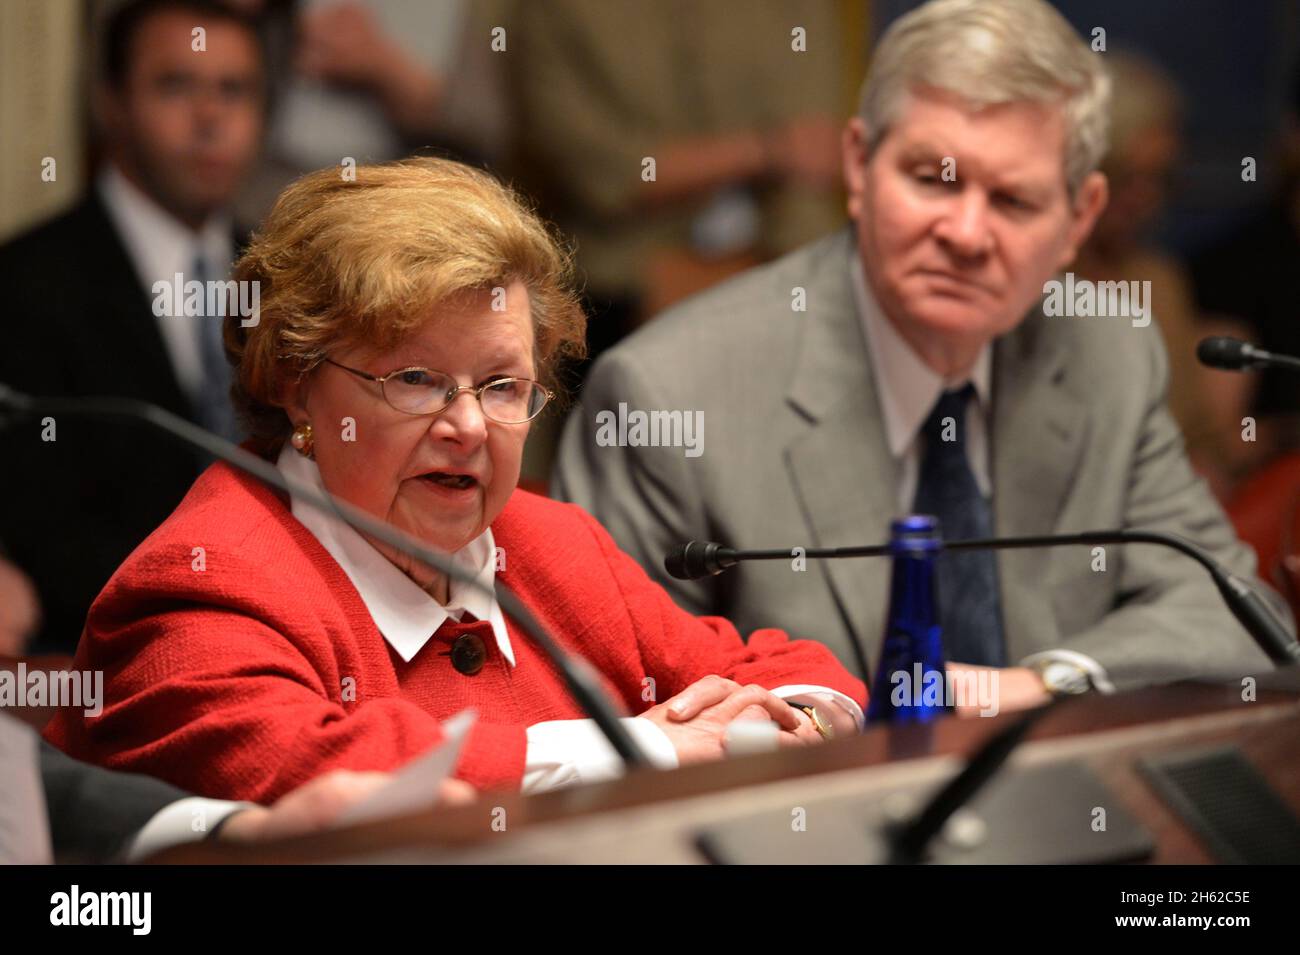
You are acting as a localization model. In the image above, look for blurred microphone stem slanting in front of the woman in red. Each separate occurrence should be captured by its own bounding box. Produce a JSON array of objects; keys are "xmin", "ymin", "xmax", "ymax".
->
[{"xmin": 0, "ymin": 383, "xmax": 651, "ymax": 768}]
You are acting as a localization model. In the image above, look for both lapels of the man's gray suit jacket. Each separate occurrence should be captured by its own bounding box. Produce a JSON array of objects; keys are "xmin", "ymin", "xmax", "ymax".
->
[{"xmin": 785, "ymin": 250, "xmax": 1089, "ymax": 659}]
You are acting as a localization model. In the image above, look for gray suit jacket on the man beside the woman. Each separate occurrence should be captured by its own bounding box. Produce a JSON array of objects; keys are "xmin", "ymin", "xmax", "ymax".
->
[{"xmin": 554, "ymin": 230, "xmax": 1290, "ymax": 689}]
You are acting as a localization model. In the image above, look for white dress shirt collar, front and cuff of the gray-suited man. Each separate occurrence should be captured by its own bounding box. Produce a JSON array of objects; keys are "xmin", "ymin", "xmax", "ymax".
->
[{"xmin": 850, "ymin": 256, "xmax": 1114, "ymax": 693}]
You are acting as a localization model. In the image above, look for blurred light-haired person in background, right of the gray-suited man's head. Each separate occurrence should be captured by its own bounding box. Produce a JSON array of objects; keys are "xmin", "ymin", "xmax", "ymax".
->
[{"xmin": 1074, "ymin": 52, "xmax": 1253, "ymax": 500}]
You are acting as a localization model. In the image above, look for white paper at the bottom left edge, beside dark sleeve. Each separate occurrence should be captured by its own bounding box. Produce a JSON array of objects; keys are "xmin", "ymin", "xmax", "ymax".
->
[{"xmin": 0, "ymin": 713, "xmax": 55, "ymax": 865}]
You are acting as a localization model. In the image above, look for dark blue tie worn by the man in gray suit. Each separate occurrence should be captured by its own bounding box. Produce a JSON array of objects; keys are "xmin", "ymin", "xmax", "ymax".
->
[{"xmin": 913, "ymin": 385, "xmax": 1006, "ymax": 667}]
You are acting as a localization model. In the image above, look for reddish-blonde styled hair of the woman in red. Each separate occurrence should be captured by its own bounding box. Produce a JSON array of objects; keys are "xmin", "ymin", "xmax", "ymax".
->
[{"xmin": 225, "ymin": 159, "xmax": 586, "ymax": 453}]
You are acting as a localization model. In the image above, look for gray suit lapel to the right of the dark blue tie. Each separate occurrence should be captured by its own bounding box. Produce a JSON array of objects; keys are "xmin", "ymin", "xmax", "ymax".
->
[{"xmin": 991, "ymin": 312, "xmax": 1089, "ymax": 654}]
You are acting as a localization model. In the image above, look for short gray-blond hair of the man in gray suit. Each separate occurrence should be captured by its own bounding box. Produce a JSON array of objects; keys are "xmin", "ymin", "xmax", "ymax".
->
[{"xmin": 859, "ymin": 0, "xmax": 1110, "ymax": 195}]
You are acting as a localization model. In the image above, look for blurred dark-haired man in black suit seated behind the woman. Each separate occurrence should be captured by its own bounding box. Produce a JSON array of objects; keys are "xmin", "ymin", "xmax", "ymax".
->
[{"xmin": 0, "ymin": 0, "xmax": 264, "ymax": 652}]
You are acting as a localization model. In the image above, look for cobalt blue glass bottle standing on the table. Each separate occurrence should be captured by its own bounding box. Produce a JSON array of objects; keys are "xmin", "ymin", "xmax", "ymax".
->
[{"xmin": 867, "ymin": 515, "xmax": 946, "ymax": 724}]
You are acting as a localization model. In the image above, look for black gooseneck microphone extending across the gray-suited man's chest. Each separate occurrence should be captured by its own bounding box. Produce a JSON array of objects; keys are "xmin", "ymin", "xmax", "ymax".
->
[{"xmin": 663, "ymin": 530, "xmax": 1300, "ymax": 667}]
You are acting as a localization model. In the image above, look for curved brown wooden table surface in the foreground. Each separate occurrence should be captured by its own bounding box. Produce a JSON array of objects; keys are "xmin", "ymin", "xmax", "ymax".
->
[{"xmin": 155, "ymin": 670, "xmax": 1300, "ymax": 864}]
